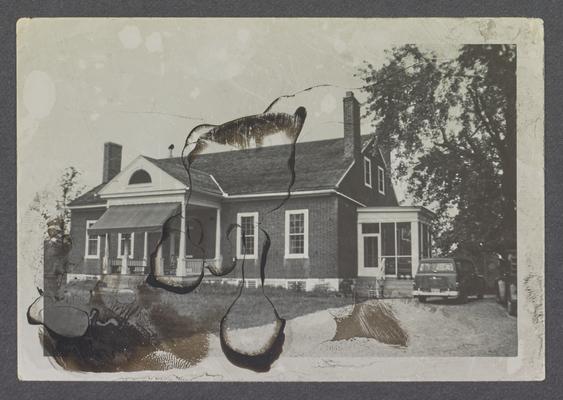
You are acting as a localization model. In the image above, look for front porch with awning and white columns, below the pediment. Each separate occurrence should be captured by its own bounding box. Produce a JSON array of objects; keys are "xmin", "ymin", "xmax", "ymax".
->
[{"xmin": 88, "ymin": 202, "xmax": 221, "ymax": 277}]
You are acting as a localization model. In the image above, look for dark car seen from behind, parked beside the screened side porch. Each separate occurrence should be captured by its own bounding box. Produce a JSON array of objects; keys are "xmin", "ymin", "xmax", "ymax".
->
[{"xmin": 413, "ymin": 258, "xmax": 485, "ymax": 303}]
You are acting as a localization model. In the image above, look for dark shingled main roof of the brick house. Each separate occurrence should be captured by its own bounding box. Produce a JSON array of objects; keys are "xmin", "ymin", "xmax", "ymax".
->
[{"xmin": 71, "ymin": 135, "xmax": 372, "ymax": 206}]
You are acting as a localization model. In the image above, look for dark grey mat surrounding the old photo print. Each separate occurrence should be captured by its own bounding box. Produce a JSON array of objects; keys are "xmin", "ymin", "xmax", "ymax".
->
[{"xmin": 0, "ymin": 0, "xmax": 563, "ymax": 400}]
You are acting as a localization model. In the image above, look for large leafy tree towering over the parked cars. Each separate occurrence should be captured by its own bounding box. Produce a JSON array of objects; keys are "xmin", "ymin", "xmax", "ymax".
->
[{"xmin": 359, "ymin": 45, "xmax": 516, "ymax": 253}]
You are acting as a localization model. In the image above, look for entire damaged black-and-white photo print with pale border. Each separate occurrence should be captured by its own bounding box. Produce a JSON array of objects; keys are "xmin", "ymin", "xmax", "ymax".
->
[{"xmin": 17, "ymin": 18, "xmax": 545, "ymax": 381}]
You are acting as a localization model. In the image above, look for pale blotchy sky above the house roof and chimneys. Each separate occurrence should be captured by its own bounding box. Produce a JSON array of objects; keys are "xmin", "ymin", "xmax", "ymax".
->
[{"xmin": 17, "ymin": 18, "xmax": 464, "ymax": 205}]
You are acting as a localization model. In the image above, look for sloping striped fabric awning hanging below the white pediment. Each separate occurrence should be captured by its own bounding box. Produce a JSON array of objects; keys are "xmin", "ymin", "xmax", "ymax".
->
[{"xmin": 88, "ymin": 203, "xmax": 180, "ymax": 235}]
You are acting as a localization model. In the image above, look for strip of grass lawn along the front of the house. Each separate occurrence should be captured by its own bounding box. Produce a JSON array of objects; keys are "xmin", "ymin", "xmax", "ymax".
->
[{"xmin": 61, "ymin": 282, "xmax": 353, "ymax": 336}]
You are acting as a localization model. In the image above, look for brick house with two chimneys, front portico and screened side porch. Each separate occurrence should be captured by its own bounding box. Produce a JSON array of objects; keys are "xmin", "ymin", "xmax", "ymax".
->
[{"xmin": 69, "ymin": 92, "xmax": 432, "ymax": 290}]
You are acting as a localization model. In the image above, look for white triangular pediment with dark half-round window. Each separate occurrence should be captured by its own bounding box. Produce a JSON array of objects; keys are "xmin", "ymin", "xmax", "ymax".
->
[{"xmin": 99, "ymin": 156, "xmax": 186, "ymax": 198}]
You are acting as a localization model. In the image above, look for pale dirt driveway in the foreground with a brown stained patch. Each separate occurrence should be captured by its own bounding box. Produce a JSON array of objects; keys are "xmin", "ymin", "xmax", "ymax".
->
[{"xmin": 209, "ymin": 297, "xmax": 517, "ymax": 357}]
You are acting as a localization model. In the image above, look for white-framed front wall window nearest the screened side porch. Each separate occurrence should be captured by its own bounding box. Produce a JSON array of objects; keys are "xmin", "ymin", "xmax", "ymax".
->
[{"xmin": 285, "ymin": 210, "xmax": 309, "ymax": 258}]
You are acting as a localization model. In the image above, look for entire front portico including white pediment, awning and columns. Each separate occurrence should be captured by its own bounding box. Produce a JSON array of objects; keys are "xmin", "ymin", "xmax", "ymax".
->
[{"xmin": 82, "ymin": 156, "xmax": 225, "ymax": 277}]
